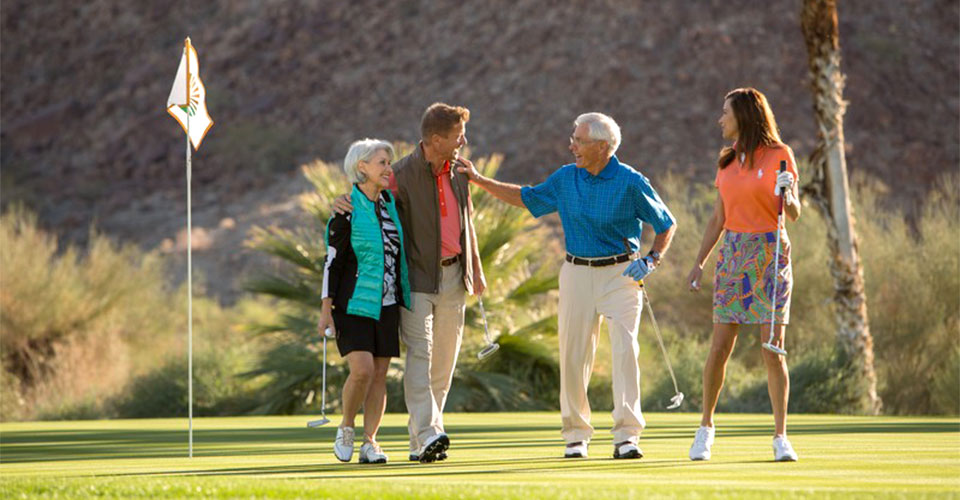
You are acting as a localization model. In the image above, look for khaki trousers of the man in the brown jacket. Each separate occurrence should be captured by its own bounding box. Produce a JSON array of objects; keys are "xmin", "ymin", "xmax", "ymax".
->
[{"xmin": 400, "ymin": 265, "xmax": 466, "ymax": 454}]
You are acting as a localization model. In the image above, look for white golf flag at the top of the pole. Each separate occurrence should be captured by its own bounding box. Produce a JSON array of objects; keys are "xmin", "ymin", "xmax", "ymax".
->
[{"xmin": 167, "ymin": 38, "xmax": 213, "ymax": 149}]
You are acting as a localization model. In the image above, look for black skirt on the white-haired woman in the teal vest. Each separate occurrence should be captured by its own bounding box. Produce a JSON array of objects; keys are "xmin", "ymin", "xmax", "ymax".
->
[{"xmin": 333, "ymin": 304, "xmax": 400, "ymax": 358}]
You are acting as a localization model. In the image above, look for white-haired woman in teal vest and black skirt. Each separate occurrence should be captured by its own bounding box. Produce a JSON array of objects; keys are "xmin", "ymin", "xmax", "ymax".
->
[{"xmin": 317, "ymin": 139, "xmax": 410, "ymax": 463}]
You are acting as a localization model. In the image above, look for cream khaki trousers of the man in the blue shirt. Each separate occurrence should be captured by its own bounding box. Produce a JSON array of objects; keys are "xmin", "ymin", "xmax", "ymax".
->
[{"xmin": 558, "ymin": 262, "xmax": 646, "ymax": 443}]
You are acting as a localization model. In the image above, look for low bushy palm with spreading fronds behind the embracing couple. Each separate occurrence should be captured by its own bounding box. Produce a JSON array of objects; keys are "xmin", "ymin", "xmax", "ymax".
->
[{"xmin": 246, "ymin": 144, "xmax": 559, "ymax": 413}]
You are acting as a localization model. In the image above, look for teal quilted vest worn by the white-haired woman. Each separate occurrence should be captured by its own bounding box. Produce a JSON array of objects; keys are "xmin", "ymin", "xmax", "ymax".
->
[{"xmin": 347, "ymin": 185, "xmax": 410, "ymax": 320}]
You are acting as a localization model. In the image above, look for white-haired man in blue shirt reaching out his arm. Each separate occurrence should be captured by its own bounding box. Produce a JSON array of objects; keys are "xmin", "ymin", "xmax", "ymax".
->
[{"xmin": 460, "ymin": 113, "xmax": 677, "ymax": 458}]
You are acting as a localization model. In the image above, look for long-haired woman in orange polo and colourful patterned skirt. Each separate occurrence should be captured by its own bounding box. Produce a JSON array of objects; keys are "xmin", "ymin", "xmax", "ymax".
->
[{"xmin": 687, "ymin": 88, "xmax": 800, "ymax": 461}]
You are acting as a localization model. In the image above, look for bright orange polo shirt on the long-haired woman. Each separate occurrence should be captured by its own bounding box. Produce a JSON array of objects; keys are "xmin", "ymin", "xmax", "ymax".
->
[{"xmin": 714, "ymin": 144, "xmax": 800, "ymax": 233}]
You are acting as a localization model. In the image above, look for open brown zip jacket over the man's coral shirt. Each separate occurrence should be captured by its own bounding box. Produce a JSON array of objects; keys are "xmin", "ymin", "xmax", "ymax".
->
[{"xmin": 392, "ymin": 144, "xmax": 477, "ymax": 294}]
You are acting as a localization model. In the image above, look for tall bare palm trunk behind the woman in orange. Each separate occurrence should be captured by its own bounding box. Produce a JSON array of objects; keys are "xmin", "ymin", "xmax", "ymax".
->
[{"xmin": 801, "ymin": 0, "xmax": 882, "ymax": 414}]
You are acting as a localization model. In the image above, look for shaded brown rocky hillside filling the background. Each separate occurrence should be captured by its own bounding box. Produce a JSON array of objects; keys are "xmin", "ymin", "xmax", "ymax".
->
[{"xmin": 0, "ymin": 0, "xmax": 960, "ymax": 296}]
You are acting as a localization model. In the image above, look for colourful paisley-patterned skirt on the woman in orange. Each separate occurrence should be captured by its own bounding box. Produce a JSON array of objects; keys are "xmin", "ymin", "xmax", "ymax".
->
[{"xmin": 713, "ymin": 231, "xmax": 793, "ymax": 325}]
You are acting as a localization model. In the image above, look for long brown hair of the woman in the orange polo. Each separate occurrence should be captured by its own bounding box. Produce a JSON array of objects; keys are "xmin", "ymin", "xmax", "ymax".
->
[{"xmin": 717, "ymin": 87, "xmax": 781, "ymax": 168}]
